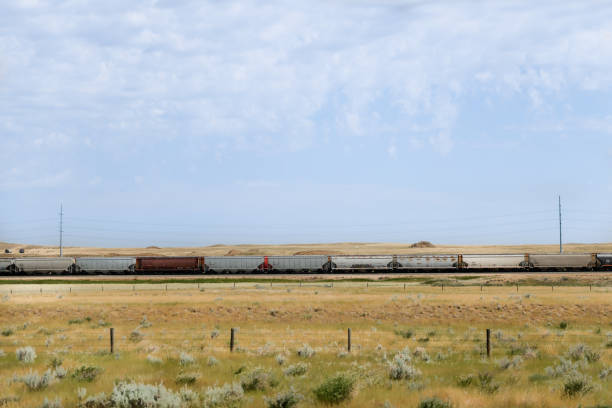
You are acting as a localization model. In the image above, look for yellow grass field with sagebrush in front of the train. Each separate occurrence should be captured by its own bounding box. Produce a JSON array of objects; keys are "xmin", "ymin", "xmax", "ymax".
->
[{"xmin": 0, "ymin": 274, "xmax": 612, "ymax": 408}]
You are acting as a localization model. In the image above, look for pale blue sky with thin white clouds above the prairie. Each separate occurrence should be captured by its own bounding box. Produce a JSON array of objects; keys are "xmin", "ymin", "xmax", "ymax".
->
[{"xmin": 0, "ymin": 0, "xmax": 612, "ymax": 247}]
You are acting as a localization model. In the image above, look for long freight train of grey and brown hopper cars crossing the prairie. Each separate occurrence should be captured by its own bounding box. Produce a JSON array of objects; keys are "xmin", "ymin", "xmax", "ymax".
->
[{"xmin": 0, "ymin": 253, "xmax": 612, "ymax": 276}]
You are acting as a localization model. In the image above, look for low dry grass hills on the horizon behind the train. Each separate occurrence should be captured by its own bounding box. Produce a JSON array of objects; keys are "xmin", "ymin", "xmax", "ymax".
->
[{"xmin": 0, "ymin": 242, "xmax": 612, "ymax": 256}]
